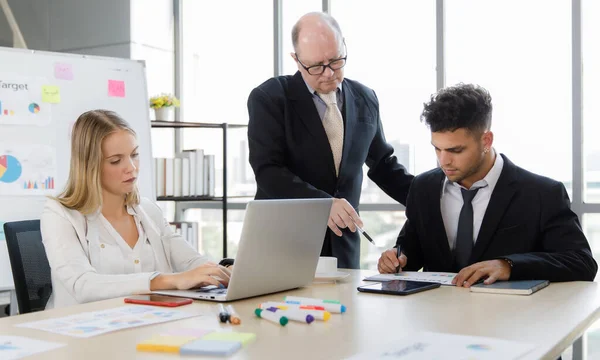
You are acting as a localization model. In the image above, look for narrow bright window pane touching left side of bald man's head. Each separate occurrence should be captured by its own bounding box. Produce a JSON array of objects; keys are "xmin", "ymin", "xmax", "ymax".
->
[{"xmin": 281, "ymin": 0, "xmax": 323, "ymax": 75}]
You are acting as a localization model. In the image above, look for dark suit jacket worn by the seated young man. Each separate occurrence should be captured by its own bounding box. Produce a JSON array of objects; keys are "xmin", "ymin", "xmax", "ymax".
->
[{"xmin": 397, "ymin": 155, "xmax": 598, "ymax": 281}]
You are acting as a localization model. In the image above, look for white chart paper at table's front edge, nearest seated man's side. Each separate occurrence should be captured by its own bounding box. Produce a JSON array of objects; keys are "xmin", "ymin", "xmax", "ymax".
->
[{"xmin": 349, "ymin": 332, "xmax": 535, "ymax": 360}]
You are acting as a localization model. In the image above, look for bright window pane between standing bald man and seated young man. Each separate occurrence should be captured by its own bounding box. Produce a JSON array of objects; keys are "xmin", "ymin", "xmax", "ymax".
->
[{"xmin": 331, "ymin": 0, "xmax": 436, "ymax": 203}]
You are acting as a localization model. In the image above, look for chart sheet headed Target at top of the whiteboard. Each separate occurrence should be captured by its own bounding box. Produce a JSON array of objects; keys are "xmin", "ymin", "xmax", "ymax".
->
[{"xmin": 0, "ymin": 73, "xmax": 52, "ymax": 126}]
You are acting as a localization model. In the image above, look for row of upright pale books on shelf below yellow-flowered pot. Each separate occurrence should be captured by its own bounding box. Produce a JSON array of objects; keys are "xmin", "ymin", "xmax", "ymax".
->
[{"xmin": 154, "ymin": 149, "xmax": 216, "ymax": 197}]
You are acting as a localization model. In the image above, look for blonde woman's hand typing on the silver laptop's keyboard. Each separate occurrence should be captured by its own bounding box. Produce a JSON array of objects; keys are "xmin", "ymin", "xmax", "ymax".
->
[{"xmin": 150, "ymin": 263, "xmax": 231, "ymax": 291}]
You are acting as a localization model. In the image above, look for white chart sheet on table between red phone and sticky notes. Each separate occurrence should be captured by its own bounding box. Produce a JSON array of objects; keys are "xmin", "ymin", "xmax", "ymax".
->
[{"xmin": 16, "ymin": 305, "xmax": 198, "ymax": 338}]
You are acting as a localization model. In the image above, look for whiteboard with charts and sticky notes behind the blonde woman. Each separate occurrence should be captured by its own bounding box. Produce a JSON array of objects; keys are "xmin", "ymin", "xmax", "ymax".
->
[{"xmin": 0, "ymin": 47, "xmax": 155, "ymax": 288}]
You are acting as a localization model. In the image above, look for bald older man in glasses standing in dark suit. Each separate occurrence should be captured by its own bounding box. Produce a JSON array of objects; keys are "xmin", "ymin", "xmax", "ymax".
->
[{"xmin": 248, "ymin": 13, "xmax": 413, "ymax": 269}]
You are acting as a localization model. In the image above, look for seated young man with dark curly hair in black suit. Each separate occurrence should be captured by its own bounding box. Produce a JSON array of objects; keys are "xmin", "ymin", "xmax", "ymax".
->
[{"xmin": 378, "ymin": 84, "xmax": 598, "ymax": 287}]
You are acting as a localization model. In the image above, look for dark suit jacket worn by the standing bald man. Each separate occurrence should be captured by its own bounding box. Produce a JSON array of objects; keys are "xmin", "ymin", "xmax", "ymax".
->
[{"xmin": 248, "ymin": 72, "xmax": 413, "ymax": 269}]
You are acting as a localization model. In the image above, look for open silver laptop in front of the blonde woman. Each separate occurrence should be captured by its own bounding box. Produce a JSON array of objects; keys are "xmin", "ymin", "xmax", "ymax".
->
[{"xmin": 153, "ymin": 199, "xmax": 333, "ymax": 301}]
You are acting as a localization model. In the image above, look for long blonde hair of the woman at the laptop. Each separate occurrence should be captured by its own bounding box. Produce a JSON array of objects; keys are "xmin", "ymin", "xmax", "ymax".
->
[{"xmin": 57, "ymin": 110, "xmax": 140, "ymax": 215}]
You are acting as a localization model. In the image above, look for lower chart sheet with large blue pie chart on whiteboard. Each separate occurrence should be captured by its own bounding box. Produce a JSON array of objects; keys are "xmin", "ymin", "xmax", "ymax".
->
[{"xmin": 0, "ymin": 143, "xmax": 56, "ymax": 196}]
